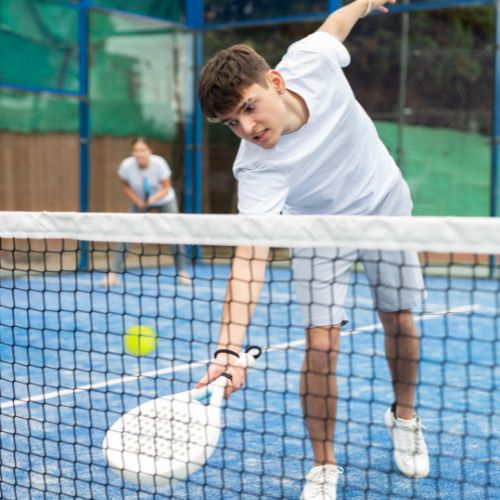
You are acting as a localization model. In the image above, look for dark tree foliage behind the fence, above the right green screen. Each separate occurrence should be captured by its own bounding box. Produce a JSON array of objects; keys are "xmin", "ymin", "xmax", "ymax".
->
[{"xmin": 205, "ymin": 6, "xmax": 495, "ymax": 132}]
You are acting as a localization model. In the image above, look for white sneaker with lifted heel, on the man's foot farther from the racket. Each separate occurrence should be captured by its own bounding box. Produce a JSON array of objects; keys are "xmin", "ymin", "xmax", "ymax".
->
[{"xmin": 384, "ymin": 405, "xmax": 429, "ymax": 479}]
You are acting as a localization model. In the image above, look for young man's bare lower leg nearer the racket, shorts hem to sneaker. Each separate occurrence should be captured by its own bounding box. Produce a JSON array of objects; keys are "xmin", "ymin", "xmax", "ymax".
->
[{"xmin": 300, "ymin": 325, "xmax": 340, "ymax": 465}]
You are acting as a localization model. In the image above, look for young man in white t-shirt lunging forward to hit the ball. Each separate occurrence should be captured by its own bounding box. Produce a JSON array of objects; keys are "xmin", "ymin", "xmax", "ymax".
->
[{"xmin": 199, "ymin": 0, "xmax": 429, "ymax": 500}]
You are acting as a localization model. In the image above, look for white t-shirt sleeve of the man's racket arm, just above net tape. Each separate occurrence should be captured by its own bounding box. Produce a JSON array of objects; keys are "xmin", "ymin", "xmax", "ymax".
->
[{"xmin": 238, "ymin": 170, "xmax": 288, "ymax": 215}]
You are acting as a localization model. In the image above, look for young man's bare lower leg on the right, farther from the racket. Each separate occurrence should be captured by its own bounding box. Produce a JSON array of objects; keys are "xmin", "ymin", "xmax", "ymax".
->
[{"xmin": 379, "ymin": 309, "xmax": 420, "ymax": 420}]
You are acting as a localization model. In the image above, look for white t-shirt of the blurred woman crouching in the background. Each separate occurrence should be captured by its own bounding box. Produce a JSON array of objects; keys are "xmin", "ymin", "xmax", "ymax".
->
[{"xmin": 118, "ymin": 155, "xmax": 175, "ymax": 207}]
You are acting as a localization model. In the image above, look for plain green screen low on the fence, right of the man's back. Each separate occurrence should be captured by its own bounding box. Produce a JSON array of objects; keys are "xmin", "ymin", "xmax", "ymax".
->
[{"xmin": 376, "ymin": 122, "xmax": 491, "ymax": 216}]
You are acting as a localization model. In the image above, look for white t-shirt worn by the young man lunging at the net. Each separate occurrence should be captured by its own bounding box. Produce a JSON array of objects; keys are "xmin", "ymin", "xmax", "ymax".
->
[{"xmin": 233, "ymin": 32, "xmax": 401, "ymax": 215}]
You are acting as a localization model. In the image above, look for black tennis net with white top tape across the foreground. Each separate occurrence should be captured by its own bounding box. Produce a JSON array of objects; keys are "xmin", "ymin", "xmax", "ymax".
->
[{"xmin": 0, "ymin": 212, "xmax": 500, "ymax": 499}]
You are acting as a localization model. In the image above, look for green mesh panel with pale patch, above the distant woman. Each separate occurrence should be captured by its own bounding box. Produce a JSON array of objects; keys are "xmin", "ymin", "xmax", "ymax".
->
[{"xmin": 89, "ymin": 12, "xmax": 186, "ymax": 139}]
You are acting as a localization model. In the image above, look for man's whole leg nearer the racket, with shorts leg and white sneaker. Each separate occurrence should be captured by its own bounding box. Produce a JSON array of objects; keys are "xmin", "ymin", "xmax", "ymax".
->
[{"xmin": 293, "ymin": 248, "xmax": 357, "ymax": 500}]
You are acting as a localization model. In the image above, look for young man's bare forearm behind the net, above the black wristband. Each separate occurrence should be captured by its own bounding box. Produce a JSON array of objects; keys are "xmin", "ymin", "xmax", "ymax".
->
[{"xmin": 217, "ymin": 247, "xmax": 269, "ymax": 352}]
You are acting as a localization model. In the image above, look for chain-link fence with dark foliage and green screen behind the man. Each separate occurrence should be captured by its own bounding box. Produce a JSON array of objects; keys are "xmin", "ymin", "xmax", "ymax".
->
[{"xmin": 204, "ymin": 7, "xmax": 494, "ymax": 216}]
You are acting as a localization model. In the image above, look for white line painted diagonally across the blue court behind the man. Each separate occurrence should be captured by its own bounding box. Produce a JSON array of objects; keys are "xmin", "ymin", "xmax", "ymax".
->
[{"xmin": 0, "ymin": 304, "xmax": 480, "ymax": 409}]
